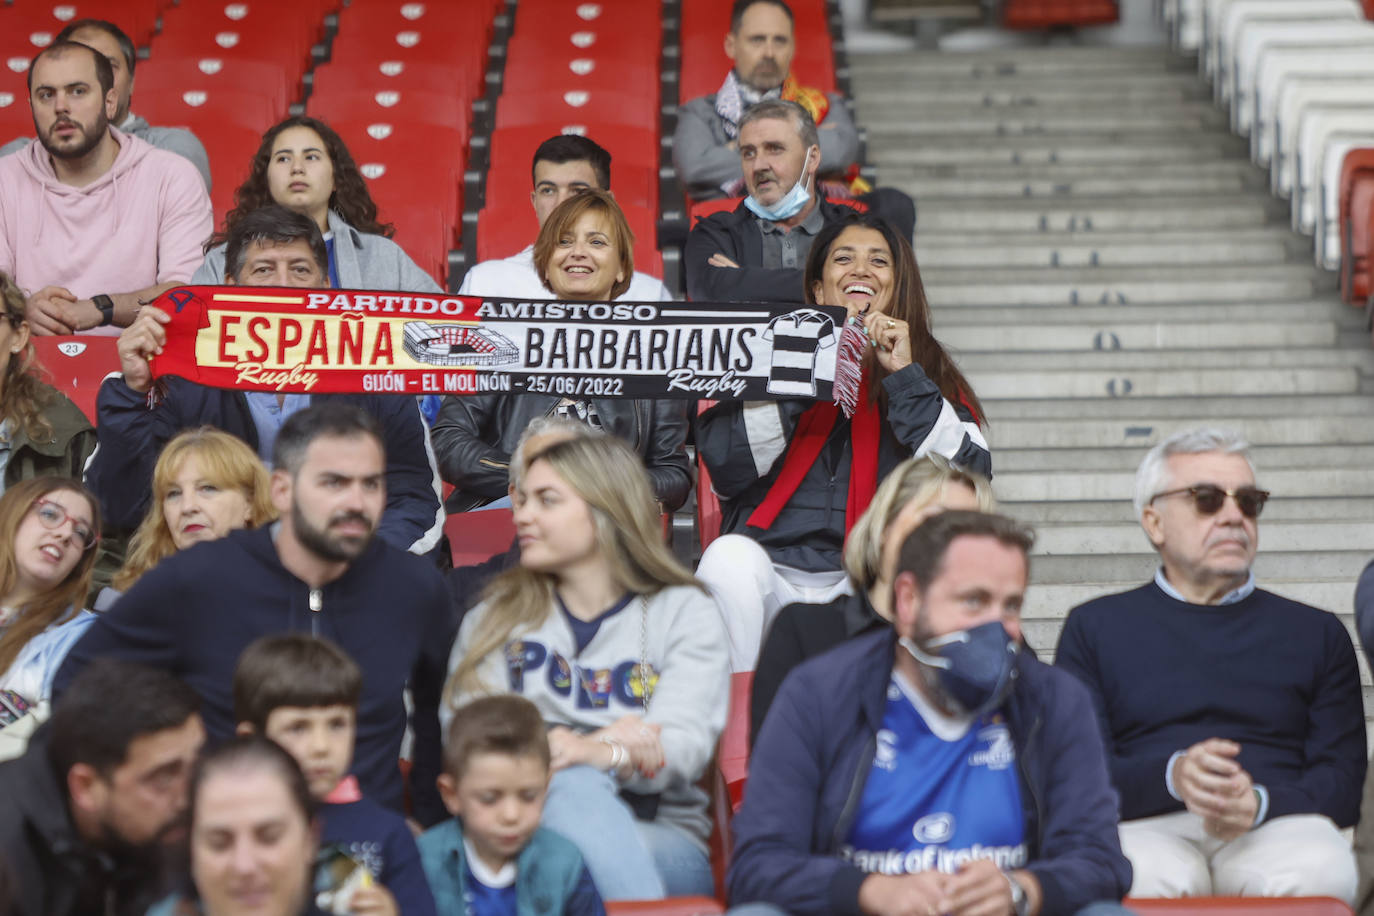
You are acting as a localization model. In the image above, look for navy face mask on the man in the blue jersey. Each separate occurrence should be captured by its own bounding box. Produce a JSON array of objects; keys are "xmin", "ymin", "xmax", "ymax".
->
[{"xmin": 899, "ymin": 621, "xmax": 1021, "ymax": 717}]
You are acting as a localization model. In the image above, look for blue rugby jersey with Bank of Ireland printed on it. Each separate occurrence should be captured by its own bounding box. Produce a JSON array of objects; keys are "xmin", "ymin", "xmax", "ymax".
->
[{"xmin": 840, "ymin": 672, "xmax": 1028, "ymax": 875}]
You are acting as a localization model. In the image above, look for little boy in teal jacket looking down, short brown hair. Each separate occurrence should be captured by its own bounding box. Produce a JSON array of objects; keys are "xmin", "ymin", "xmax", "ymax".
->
[{"xmin": 419, "ymin": 696, "xmax": 606, "ymax": 916}]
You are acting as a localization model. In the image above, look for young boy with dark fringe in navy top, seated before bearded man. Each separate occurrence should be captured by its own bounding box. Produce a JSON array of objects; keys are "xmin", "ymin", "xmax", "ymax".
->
[{"xmin": 234, "ymin": 633, "xmax": 436, "ymax": 916}]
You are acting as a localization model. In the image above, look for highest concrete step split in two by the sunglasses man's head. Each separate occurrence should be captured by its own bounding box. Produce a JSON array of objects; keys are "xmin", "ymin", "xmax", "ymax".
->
[{"xmin": 989, "ymin": 444, "xmax": 1374, "ymax": 472}]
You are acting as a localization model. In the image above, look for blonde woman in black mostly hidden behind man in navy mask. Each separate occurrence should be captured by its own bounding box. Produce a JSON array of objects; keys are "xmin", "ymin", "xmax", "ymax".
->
[{"xmin": 749, "ymin": 455, "xmax": 996, "ymax": 744}]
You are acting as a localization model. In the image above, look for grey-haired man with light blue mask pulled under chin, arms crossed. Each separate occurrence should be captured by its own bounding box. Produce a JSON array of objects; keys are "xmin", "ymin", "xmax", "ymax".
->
[{"xmin": 684, "ymin": 99, "xmax": 915, "ymax": 302}]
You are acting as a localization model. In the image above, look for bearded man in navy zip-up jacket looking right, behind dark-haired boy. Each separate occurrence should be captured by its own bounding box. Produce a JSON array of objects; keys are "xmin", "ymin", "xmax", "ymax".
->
[{"xmin": 54, "ymin": 401, "xmax": 453, "ymax": 824}]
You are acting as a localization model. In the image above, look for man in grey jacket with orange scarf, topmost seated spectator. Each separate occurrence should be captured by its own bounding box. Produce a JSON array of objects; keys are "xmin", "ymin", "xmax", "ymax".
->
[{"xmin": 673, "ymin": 0, "xmax": 867, "ymax": 201}]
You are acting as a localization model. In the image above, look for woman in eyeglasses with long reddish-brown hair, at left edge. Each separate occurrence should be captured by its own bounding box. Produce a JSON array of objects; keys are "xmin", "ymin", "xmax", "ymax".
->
[{"xmin": 0, "ymin": 477, "xmax": 100, "ymax": 725}]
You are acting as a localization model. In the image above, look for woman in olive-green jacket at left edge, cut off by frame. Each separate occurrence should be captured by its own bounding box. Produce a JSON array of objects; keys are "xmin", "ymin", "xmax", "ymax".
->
[{"xmin": 0, "ymin": 273, "xmax": 95, "ymax": 492}]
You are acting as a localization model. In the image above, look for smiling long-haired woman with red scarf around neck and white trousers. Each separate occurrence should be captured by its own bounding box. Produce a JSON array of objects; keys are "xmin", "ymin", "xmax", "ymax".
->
[{"xmin": 697, "ymin": 214, "xmax": 992, "ymax": 672}]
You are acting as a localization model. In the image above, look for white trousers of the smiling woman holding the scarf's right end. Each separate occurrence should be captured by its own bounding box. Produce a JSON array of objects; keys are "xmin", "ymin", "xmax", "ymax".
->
[{"xmin": 697, "ymin": 534, "xmax": 852, "ymax": 673}]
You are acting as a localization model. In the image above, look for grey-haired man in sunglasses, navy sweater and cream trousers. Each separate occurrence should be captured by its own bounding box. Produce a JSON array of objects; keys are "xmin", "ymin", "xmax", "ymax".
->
[{"xmin": 1055, "ymin": 428, "xmax": 1366, "ymax": 902}]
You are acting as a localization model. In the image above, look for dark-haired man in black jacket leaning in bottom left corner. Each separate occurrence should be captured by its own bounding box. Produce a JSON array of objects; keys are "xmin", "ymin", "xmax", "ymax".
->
[{"xmin": 0, "ymin": 659, "xmax": 205, "ymax": 916}]
